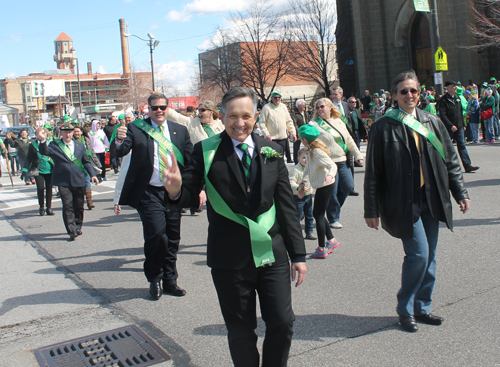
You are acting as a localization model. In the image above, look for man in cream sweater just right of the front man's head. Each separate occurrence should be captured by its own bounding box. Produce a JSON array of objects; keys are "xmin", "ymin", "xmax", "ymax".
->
[{"xmin": 259, "ymin": 91, "xmax": 297, "ymax": 163}]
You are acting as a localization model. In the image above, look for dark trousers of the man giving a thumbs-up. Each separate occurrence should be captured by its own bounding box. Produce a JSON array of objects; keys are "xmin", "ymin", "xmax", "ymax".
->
[{"xmin": 137, "ymin": 186, "xmax": 181, "ymax": 285}]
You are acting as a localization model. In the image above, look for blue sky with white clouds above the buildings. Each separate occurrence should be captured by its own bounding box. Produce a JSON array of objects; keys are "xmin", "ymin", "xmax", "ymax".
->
[{"xmin": 0, "ymin": 0, "xmax": 287, "ymax": 95}]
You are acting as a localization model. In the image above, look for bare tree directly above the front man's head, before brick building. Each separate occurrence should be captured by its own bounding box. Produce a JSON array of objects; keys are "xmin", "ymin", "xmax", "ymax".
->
[{"xmin": 230, "ymin": 0, "xmax": 291, "ymax": 102}]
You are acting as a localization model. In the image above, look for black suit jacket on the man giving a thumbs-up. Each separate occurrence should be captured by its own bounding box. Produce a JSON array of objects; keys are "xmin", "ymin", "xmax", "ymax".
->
[{"xmin": 114, "ymin": 118, "xmax": 193, "ymax": 208}]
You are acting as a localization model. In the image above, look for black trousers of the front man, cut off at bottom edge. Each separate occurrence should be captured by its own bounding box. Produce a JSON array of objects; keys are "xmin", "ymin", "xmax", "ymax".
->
[{"xmin": 212, "ymin": 259, "xmax": 295, "ymax": 367}]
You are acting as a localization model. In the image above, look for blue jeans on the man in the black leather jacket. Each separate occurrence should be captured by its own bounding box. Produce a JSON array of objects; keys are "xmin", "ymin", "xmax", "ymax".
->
[{"xmin": 397, "ymin": 201, "xmax": 439, "ymax": 316}]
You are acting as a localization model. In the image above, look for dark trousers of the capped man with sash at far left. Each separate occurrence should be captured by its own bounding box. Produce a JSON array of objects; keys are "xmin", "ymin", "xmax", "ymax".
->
[{"xmin": 59, "ymin": 186, "xmax": 85, "ymax": 234}]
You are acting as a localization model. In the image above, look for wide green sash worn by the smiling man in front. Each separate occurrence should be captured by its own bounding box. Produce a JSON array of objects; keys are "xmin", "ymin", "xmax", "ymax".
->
[{"xmin": 201, "ymin": 134, "xmax": 276, "ymax": 268}]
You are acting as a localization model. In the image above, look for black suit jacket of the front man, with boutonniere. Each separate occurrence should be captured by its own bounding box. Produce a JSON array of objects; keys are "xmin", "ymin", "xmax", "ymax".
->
[{"xmin": 175, "ymin": 131, "xmax": 306, "ymax": 270}]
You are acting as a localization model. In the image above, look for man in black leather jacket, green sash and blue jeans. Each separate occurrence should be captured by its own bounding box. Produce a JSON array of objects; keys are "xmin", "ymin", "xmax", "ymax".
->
[{"xmin": 364, "ymin": 71, "xmax": 470, "ymax": 332}]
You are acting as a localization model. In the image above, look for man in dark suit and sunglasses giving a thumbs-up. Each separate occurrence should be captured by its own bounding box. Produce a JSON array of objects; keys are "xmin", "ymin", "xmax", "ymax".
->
[{"xmin": 115, "ymin": 93, "xmax": 193, "ymax": 300}]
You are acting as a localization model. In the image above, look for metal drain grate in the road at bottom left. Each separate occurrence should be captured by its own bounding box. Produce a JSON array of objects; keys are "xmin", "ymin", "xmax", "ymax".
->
[{"xmin": 34, "ymin": 325, "xmax": 170, "ymax": 367}]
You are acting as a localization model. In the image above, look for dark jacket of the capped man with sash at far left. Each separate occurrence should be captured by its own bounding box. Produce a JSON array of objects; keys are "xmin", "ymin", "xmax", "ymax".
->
[{"xmin": 39, "ymin": 140, "xmax": 95, "ymax": 187}]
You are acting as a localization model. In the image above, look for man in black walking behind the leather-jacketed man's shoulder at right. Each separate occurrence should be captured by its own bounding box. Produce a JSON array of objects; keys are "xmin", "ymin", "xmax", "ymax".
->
[{"xmin": 438, "ymin": 80, "xmax": 479, "ymax": 172}]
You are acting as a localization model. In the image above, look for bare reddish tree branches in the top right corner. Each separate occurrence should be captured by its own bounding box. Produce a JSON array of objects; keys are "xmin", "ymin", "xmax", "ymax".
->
[{"xmin": 469, "ymin": 0, "xmax": 500, "ymax": 49}]
